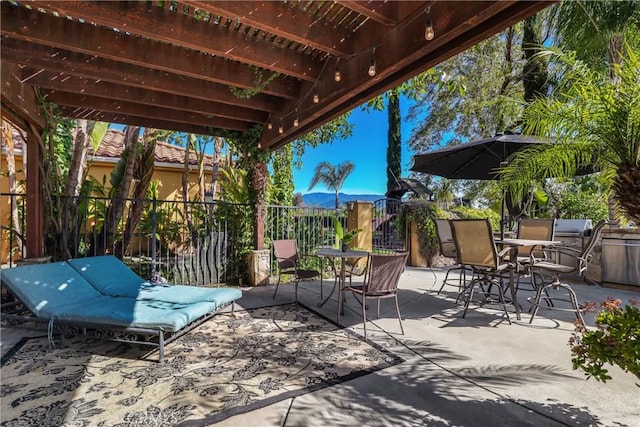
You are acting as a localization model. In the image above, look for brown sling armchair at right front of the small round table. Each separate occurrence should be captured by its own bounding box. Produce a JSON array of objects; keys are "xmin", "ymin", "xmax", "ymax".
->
[{"xmin": 344, "ymin": 252, "xmax": 408, "ymax": 341}]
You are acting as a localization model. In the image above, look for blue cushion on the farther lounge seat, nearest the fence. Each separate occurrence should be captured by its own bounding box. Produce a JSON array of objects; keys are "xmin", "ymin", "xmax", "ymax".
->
[{"xmin": 67, "ymin": 255, "xmax": 242, "ymax": 308}]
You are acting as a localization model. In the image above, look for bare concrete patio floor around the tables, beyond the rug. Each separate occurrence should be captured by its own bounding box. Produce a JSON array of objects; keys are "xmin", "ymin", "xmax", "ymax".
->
[{"xmin": 0, "ymin": 267, "xmax": 640, "ymax": 427}]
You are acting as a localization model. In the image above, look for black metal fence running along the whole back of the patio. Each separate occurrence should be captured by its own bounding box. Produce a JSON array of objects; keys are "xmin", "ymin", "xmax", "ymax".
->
[{"xmin": 0, "ymin": 193, "xmax": 401, "ymax": 285}]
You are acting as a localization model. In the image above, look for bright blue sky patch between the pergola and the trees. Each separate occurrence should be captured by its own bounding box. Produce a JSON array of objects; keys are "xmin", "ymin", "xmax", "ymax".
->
[{"xmin": 293, "ymin": 98, "xmax": 413, "ymax": 194}]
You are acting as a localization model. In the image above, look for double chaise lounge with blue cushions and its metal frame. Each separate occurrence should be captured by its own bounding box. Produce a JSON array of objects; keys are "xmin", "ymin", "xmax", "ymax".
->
[{"xmin": 1, "ymin": 255, "xmax": 242, "ymax": 362}]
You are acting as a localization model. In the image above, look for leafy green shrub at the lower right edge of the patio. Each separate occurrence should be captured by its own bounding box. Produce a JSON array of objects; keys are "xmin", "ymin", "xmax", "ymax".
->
[{"xmin": 569, "ymin": 298, "xmax": 640, "ymax": 382}]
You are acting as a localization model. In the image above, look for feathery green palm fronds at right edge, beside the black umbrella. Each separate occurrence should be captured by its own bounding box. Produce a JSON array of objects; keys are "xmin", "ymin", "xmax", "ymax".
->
[{"xmin": 502, "ymin": 43, "xmax": 640, "ymax": 224}]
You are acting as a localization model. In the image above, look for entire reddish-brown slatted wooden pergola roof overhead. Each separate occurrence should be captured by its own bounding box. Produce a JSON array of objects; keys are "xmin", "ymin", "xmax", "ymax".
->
[{"xmin": 0, "ymin": 0, "xmax": 551, "ymax": 258}]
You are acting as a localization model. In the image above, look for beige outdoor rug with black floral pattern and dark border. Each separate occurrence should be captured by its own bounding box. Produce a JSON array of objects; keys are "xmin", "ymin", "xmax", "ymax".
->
[{"xmin": 0, "ymin": 304, "xmax": 402, "ymax": 426}]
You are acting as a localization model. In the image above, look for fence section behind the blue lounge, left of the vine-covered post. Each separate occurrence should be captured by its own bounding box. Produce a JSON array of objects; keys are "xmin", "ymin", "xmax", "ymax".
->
[{"xmin": 0, "ymin": 193, "xmax": 252, "ymax": 285}]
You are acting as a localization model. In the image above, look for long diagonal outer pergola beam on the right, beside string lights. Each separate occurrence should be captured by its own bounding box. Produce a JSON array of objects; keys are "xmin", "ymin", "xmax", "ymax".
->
[{"xmin": 260, "ymin": 1, "xmax": 546, "ymax": 149}]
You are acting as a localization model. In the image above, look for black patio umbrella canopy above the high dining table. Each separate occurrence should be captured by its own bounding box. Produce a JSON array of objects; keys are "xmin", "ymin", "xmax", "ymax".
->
[{"xmin": 411, "ymin": 134, "xmax": 548, "ymax": 180}]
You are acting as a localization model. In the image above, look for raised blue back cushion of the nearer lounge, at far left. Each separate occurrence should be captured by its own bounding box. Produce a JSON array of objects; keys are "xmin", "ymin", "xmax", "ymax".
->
[{"xmin": 0, "ymin": 262, "xmax": 102, "ymax": 318}]
